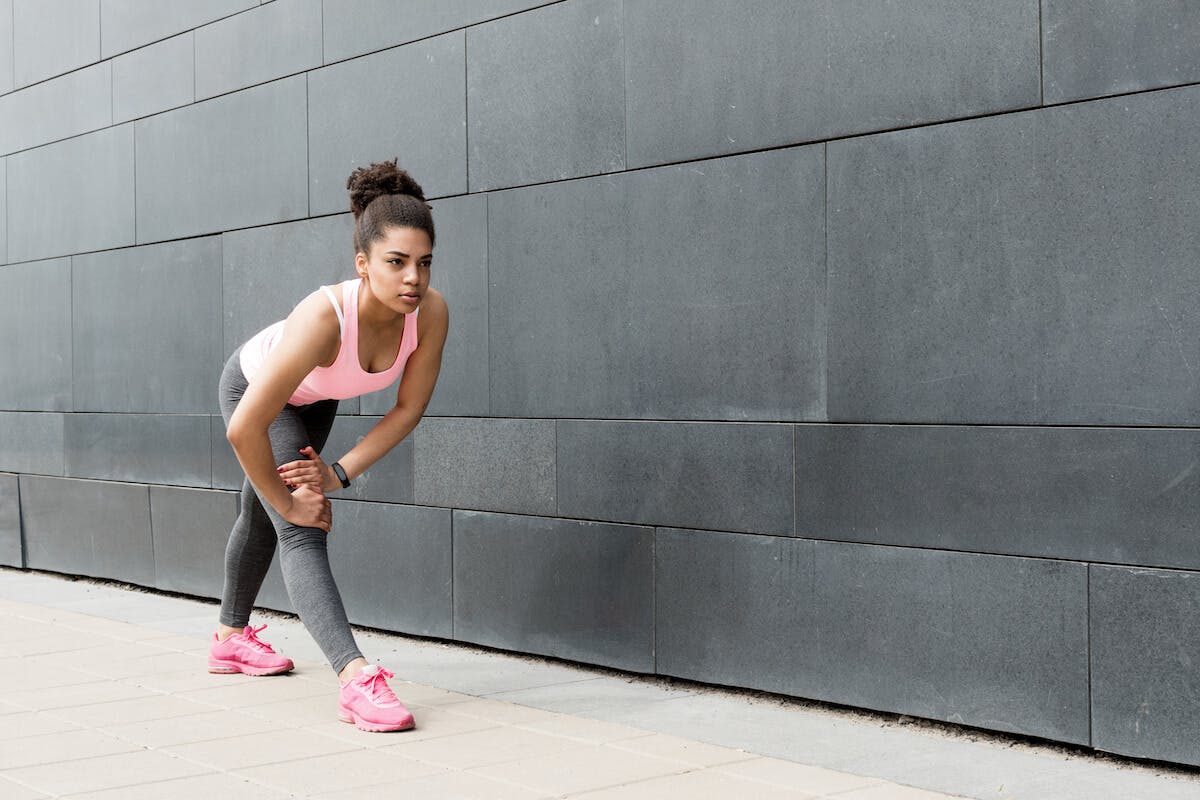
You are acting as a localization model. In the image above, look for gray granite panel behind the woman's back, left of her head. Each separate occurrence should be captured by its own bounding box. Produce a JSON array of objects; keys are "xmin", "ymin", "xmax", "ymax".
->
[{"xmin": 221, "ymin": 215, "xmax": 354, "ymax": 359}]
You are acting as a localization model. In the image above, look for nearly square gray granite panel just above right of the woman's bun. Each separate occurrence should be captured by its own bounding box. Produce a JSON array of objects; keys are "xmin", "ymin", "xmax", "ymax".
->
[{"xmin": 467, "ymin": 0, "xmax": 625, "ymax": 192}]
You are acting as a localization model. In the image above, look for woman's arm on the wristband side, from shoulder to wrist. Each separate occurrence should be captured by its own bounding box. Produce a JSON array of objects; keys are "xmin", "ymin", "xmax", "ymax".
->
[{"xmin": 329, "ymin": 289, "xmax": 450, "ymax": 486}]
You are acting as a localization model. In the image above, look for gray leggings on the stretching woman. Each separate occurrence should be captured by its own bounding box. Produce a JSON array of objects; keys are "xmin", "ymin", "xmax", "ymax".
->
[{"xmin": 220, "ymin": 348, "xmax": 362, "ymax": 672}]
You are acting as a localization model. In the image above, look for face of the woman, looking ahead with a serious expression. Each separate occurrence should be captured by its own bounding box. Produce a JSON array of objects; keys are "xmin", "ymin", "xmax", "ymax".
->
[{"xmin": 354, "ymin": 227, "xmax": 433, "ymax": 314}]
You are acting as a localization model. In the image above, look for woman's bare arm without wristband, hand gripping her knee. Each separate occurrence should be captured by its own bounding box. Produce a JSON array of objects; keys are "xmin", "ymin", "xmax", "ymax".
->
[{"xmin": 226, "ymin": 291, "xmax": 340, "ymax": 533}]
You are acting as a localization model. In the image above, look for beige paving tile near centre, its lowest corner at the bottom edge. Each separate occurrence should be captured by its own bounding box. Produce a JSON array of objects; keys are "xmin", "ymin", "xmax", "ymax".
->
[{"xmin": 473, "ymin": 746, "xmax": 691, "ymax": 796}]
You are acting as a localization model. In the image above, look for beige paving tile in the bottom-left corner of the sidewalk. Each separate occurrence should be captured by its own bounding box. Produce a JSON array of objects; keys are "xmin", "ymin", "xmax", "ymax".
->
[{"xmin": 8, "ymin": 750, "xmax": 206, "ymax": 796}]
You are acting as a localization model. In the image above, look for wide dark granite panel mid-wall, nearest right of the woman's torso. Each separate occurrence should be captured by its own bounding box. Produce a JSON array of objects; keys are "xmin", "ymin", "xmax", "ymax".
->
[{"xmin": 488, "ymin": 146, "xmax": 826, "ymax": 420}]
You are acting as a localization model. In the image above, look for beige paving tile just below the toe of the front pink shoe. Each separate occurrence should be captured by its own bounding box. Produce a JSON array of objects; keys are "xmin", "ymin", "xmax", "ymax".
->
[{"xmin": 384, "ymin": 728, "xmax": 580, "ymax": 770}]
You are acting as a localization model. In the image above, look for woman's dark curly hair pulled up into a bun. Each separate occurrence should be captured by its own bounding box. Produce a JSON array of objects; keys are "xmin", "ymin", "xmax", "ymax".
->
[{"xmin": 346, "ymin": 158, "xmax": 434, "ymax": 253}]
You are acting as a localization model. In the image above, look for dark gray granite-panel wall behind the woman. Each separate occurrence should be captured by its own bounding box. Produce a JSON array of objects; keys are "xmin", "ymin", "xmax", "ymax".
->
[{"xmin": 0, "ymin": 0, "xmax": 1200, "ymax": 764}]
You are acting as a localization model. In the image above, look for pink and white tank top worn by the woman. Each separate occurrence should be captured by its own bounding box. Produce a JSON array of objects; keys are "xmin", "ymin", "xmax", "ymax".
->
[{"xmin": 241, "ymin": 278, "xmax": 420, "ymax": 405}]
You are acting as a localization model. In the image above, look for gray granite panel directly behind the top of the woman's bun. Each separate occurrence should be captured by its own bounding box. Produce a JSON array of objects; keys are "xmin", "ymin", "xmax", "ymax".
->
[{"xmin": 308, "ymin": 32, "xmax": 467, "ymax": 213}]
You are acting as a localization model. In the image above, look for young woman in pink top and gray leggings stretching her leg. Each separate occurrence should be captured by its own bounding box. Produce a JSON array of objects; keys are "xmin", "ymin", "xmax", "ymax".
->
[{"xmin": 209, "ymin": 161, "xmax": 448, "ymax": 730}]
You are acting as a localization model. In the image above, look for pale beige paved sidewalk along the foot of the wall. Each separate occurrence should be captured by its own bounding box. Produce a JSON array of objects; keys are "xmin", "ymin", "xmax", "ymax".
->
[{"xmin": 0, "ymin": 569, "xmax": 1200, "ymax": 800}]
